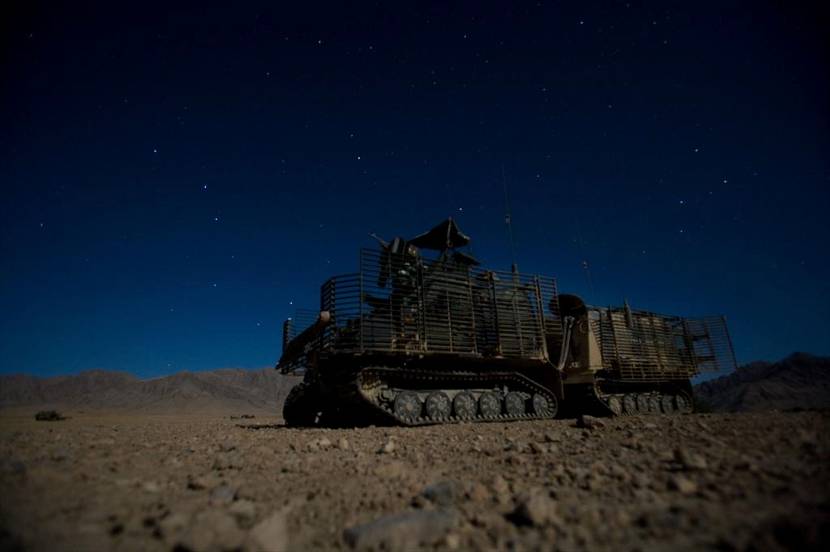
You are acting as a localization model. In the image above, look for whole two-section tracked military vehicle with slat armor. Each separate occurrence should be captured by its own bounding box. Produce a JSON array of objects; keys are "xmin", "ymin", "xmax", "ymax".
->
[{"xmin": 277, "ymin": 219, "xmax": 735, "ymax": 426}]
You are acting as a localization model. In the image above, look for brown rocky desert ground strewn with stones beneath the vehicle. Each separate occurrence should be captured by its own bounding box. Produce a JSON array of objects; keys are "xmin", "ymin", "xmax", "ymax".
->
[{"xmin": 0, "ymin": 412, "xmax": 830, "ymax": 550}]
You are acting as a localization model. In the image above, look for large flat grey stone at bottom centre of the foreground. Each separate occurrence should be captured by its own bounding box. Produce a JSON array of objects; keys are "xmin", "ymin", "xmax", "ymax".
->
[{"xmin": 343, "ymin": 510, "xmax": 458, "ymax": 550}]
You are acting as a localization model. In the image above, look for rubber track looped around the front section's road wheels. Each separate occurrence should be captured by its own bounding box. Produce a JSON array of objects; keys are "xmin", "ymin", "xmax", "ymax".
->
[{"xmin": 355, "ymin": 367, "xmax": 559, "ymax": 426}]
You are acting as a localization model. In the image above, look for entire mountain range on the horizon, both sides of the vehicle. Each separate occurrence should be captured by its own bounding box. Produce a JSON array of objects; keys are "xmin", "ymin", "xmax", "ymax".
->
[{"xmin": 0, "ymin": 353, "xmax": 830, "ymax": 414}]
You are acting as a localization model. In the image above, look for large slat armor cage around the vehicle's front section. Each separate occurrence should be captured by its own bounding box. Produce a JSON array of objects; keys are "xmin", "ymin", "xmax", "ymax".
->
[{"xmin": 320, "ymin": 249, "xmax": 561, "ymax": 359}]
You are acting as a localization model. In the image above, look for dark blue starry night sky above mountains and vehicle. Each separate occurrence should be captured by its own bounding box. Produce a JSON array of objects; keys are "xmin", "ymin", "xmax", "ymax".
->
[{"xmin": 0, "ymin": 1, "xmax": 830, "ymax": 377}]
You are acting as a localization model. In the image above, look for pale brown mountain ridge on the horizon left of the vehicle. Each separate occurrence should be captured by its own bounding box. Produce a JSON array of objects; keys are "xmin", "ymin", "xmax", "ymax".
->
[{"xmin": 0, "ymin": 368, "xmax": 300, "ymax": 414}]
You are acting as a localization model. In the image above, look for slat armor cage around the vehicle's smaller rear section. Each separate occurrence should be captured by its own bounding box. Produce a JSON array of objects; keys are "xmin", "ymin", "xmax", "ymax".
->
[{"xmin": 592, "ymin": 306, "xmax": 736, "ymax": 381}]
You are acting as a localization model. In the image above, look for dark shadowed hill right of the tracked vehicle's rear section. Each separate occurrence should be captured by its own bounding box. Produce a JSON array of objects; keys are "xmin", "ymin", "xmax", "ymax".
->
[{"xmin": 695, "ymin": 353, "xmax": 830, "ymax": 412}]
